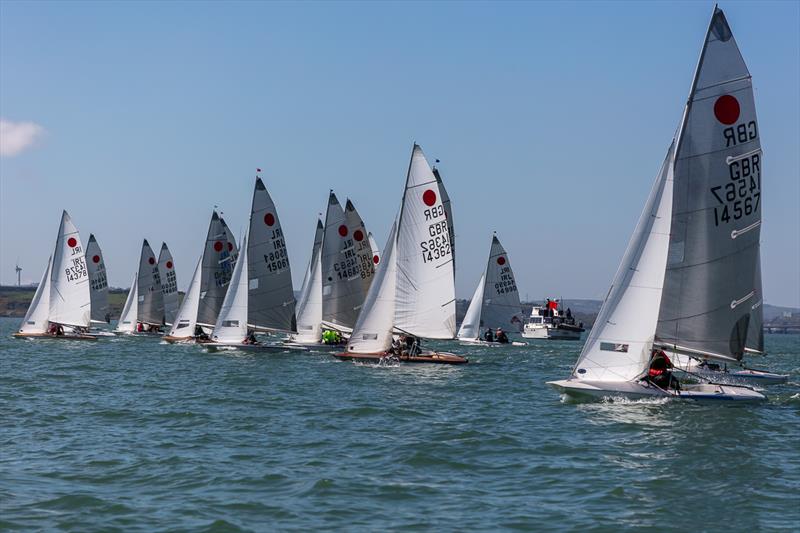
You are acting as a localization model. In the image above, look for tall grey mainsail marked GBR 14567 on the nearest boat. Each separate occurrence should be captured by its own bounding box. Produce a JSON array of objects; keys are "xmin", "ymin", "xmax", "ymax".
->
[{"xmin": 656, "ymin": 8, "xmax": 762, "ymax": 360}]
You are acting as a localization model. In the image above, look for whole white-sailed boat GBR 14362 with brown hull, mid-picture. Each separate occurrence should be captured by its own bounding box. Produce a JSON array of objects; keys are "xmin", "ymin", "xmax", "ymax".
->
[{"xmin": 336, "ymin": 144, "xmax": 467, "ymax": 364}]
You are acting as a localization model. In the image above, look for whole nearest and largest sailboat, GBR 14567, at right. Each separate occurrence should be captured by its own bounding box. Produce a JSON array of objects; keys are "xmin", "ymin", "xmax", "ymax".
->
[{"xmin": 549, "ymin": 7, "xmax": 766, "ymax": 401}]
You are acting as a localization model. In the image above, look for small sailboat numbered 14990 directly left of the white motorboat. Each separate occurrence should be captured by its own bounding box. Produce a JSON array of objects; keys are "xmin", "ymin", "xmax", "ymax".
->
[{"xmin": 458, "ymin": 235, "xmax": 526, "ymax": 346}]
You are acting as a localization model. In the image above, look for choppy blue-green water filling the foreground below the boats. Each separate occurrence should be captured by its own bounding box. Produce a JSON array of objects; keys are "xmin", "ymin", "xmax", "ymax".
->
[{"xmin": 0, "ymin": 319, "xmax": 800, "ymax": 531}]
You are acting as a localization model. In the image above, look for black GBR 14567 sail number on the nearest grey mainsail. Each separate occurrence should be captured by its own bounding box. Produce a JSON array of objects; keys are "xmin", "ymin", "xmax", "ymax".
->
[{"xmin": 711, "ymin": 153, "xmax": 761, "ymax": 226}]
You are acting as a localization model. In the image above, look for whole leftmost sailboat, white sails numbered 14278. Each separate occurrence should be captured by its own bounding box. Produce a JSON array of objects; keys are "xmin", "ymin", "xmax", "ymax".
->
[{"xmin": 14, "ymin": 211, "xmax": 97, "ymax": 340}]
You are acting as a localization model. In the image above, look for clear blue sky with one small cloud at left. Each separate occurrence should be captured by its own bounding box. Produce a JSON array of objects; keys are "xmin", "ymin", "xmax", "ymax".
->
[{"xmin": 0, "ymin": 0, "xmax": 800, "ymax": 307}]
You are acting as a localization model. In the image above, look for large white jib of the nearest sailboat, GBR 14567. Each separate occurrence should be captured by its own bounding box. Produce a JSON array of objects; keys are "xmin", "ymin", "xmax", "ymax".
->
[{"xmin": 573, "ymin": 143, "xmax": 675, "ymax": 381}]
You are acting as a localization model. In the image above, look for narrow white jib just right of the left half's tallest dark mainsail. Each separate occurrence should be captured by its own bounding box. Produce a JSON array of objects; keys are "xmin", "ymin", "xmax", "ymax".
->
[{"xmin": 292, "ymin": 219, "xmax": 325, "ymax": 343}]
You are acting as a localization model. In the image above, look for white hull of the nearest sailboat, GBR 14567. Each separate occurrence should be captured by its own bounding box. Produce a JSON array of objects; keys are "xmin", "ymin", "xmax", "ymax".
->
[{"xmin": 547, "ymin": 379, "xmax": 767, "ymax": 402}]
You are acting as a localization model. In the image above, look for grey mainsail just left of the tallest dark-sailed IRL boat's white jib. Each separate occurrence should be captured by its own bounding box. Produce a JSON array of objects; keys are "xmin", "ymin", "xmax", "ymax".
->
[{"xmin": 197, "ymin": 211, "xmax": 232, "ymax": 328}]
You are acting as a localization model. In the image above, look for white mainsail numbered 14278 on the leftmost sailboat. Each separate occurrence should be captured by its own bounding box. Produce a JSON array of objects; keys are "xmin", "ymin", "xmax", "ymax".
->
[{"xmin": 49, "ymin": 211, "xmax": 92, "ymax": 328}]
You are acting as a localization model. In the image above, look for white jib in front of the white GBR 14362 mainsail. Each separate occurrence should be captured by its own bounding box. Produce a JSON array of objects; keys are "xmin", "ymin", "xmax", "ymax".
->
[{"xmin": 347, "ymin": 222, "xmax": 397, "ymax": 354}]
